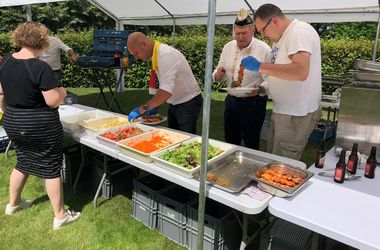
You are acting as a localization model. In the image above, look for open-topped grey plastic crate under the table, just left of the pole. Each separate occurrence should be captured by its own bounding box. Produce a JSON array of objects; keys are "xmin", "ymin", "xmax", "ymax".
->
[{"xmin": 157, "ymin": 186, "xmax": 198, "ymax": 246}]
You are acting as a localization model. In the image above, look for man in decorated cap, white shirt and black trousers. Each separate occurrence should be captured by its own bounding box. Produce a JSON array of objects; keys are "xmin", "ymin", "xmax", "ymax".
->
[{"xmin": 213, "ymin": 9, "xmax": 271, "ymax": 149}]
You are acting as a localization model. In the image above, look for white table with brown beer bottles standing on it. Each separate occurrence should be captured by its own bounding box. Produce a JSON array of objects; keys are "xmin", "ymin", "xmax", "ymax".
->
[{"xmin": 269, "ymin": 146, "xmax": 380, "ymax": 250}]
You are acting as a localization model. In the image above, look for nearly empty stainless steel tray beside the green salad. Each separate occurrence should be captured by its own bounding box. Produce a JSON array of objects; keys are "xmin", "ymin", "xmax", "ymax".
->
[{"xmin": 194, "ymin": 150, "xmax": 274, "ymax": 193}]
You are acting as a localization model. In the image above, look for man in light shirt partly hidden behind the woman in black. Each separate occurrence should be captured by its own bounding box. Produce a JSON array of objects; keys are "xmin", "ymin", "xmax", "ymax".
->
[{"xmin": 39, "ymin": 36, "xmax": 78, "ymax": 82}]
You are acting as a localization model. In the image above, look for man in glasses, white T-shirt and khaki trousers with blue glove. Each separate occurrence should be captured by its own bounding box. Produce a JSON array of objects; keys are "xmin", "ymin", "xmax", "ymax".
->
[{"xmin": 242, "ymin": 4, "xmax": 322, "ymax": 159}]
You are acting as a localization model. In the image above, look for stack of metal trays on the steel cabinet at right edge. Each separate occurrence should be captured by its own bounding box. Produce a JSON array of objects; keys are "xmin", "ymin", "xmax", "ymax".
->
[{"xmin": 350, "ymin": 59, "xmax": 380, "ymax": 89}]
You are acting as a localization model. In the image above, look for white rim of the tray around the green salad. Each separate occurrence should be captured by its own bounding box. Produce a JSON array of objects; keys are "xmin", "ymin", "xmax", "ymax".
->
[{"xmin": 152, "ymin": 136, "xmax": 236, "ymax": 178}]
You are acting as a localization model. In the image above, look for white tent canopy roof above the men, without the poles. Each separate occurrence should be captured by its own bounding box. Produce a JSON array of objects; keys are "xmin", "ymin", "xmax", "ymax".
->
[{"xmin": 87, "ymin": 0, "xmax": 379, "ymax": 25}]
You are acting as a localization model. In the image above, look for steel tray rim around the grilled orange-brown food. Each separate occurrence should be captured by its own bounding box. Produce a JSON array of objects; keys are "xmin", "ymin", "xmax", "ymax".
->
[{"xmin": 250, "ymin": 162, "xmax": 314, "ymax": 197}]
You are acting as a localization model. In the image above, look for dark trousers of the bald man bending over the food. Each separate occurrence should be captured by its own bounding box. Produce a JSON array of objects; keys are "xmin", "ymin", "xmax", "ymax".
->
[{"xmin": 168, "ymin": 94, "xmax": 202, "ymax": 134}]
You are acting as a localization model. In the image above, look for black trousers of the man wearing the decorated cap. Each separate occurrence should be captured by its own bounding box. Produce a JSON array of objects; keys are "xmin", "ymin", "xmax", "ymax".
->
[{"xmin": 224, "ymin": 95, "xmax": 268, "ymax": 149}]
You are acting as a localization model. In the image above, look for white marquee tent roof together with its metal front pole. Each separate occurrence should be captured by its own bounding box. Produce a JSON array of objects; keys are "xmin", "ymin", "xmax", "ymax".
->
[{"xmin": 0, "ymin": 0, "xmax": 380, "ymax": 249}]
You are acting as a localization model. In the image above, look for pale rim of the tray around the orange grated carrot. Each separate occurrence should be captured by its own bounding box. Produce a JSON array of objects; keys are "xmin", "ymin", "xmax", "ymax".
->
[{"xmin": 117, "ymin": 129, "xmax": 191, "ymax": 162}]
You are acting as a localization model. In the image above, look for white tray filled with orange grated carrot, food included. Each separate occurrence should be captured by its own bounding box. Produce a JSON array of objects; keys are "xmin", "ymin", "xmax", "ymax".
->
[{"xmin": 117, "ymin": 129, "xmax": 191, "ymax": 162}]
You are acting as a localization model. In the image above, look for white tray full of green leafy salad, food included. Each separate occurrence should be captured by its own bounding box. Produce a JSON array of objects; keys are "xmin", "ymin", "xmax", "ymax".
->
[{"xmin": 152, "ymin": 136, "xmax": 236, "ymax": 178}]
